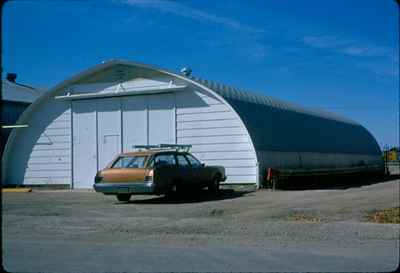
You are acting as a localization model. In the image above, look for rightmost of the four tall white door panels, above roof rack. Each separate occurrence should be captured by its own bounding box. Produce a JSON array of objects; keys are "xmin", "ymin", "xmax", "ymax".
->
[{"xmin": 148, "ymin": 94, "xmax": 176, "ymax": 145}]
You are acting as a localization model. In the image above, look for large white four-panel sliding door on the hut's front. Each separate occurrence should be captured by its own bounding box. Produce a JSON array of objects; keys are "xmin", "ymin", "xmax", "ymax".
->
[{"xmin": 72, "ymin": 94, "xmax": 176, "ymax": 188}]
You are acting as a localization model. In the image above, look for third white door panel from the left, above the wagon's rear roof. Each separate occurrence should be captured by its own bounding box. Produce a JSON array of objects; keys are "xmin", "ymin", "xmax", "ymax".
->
[{"xmin": 121, "ymin": 96, "xmax": 148, "ymax": 152}]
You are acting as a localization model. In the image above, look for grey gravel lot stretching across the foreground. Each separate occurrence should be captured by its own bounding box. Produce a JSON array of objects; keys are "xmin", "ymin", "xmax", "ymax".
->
[{"xmin": 2, "ymin": 175, "xmax": 399, "ymax": 272}]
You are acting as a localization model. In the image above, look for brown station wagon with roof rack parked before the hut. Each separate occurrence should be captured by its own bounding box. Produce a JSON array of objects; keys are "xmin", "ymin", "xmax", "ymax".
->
[{"xmin": 93, "ymin": 144, "xmax": 226, "ymax": 201}]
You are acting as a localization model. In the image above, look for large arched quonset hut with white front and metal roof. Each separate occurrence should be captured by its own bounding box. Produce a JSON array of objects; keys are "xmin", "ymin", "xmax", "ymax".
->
[{"xmin": 2, "ymin": 60, "xmax": 383, "ymax": 188}]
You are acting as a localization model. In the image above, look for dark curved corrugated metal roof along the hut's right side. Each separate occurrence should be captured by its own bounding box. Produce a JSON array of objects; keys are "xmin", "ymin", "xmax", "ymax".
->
[{"xmin": 188, "ymin": 77, "xmax": 381, "ymax": 155}]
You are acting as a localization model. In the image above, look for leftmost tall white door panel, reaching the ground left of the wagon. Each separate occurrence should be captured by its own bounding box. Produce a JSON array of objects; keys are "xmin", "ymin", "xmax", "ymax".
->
[{"xmin": 72, "ymin": 100, "xmax": 97, "ymax": 188}]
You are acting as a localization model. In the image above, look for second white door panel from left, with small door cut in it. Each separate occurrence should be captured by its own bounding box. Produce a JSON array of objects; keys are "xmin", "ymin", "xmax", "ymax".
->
[{"xmin": 97, "ymin": 98, "xmax": 121, "ymax": 170}]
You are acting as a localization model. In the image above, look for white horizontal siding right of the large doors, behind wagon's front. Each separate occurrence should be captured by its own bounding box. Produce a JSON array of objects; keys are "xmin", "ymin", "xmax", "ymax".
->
[{"xmin": 176, "ymin": 88, "xmax": 258, "ymax": 183}]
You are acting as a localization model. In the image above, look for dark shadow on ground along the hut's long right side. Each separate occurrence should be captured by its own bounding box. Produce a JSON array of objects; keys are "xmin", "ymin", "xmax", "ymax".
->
[{"xmin": 276, "ymin": 174, "xmax": 400, "ymax": 190}]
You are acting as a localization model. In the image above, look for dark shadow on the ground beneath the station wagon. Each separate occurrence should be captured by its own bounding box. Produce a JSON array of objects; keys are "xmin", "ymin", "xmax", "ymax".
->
[{"xmin": 116, "ymin": 189, "xmax": 251, "ymax": 205}]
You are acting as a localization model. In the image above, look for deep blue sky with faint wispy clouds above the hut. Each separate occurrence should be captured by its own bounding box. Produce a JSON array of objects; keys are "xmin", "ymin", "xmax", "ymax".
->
[{"xmin": 2, "ymin": 0, "xmax": 399, "ymax": 147}]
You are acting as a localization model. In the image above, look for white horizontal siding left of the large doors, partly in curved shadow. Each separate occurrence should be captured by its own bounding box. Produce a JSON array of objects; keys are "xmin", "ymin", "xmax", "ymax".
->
[{"xmin": 5, "ymin": 99, "xmax": 71, "ymax": 184}]
